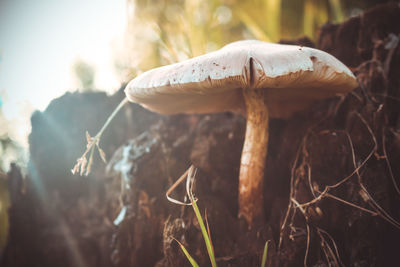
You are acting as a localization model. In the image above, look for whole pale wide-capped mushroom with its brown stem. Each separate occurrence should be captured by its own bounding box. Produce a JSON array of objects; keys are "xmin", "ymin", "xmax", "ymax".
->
[{"xmin": 125, "ymin": 40, "xmax": 357, "ymax": 227}]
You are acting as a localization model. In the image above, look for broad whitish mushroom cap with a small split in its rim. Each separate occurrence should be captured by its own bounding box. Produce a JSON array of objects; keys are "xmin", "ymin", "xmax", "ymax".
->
[{"xmin": 125, "ymin": 40, "xmax": 357, "ymax": 117}]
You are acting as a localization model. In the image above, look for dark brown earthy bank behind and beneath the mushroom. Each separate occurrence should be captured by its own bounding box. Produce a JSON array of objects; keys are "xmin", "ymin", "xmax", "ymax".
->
[{"xmin": 1, "ymin": 3, "xmax": 400, "ymax": 267}]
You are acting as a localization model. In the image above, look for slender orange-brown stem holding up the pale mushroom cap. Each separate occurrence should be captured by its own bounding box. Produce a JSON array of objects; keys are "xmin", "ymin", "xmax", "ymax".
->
[{"xmin": 239, "ymin": 88, "xmax": 269, "ymax": 228}]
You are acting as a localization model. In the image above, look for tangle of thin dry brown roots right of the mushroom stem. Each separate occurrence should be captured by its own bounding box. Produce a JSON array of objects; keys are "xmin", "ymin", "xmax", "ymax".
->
[{"xmin": 278, "ymin": 113, "xmax": 400, "ymax": 266}]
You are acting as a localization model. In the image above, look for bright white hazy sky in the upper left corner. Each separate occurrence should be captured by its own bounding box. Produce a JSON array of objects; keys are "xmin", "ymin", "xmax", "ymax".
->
[{"xmin": 0, "ymin": 0, "xmax": 126, "ymax": 149}]
